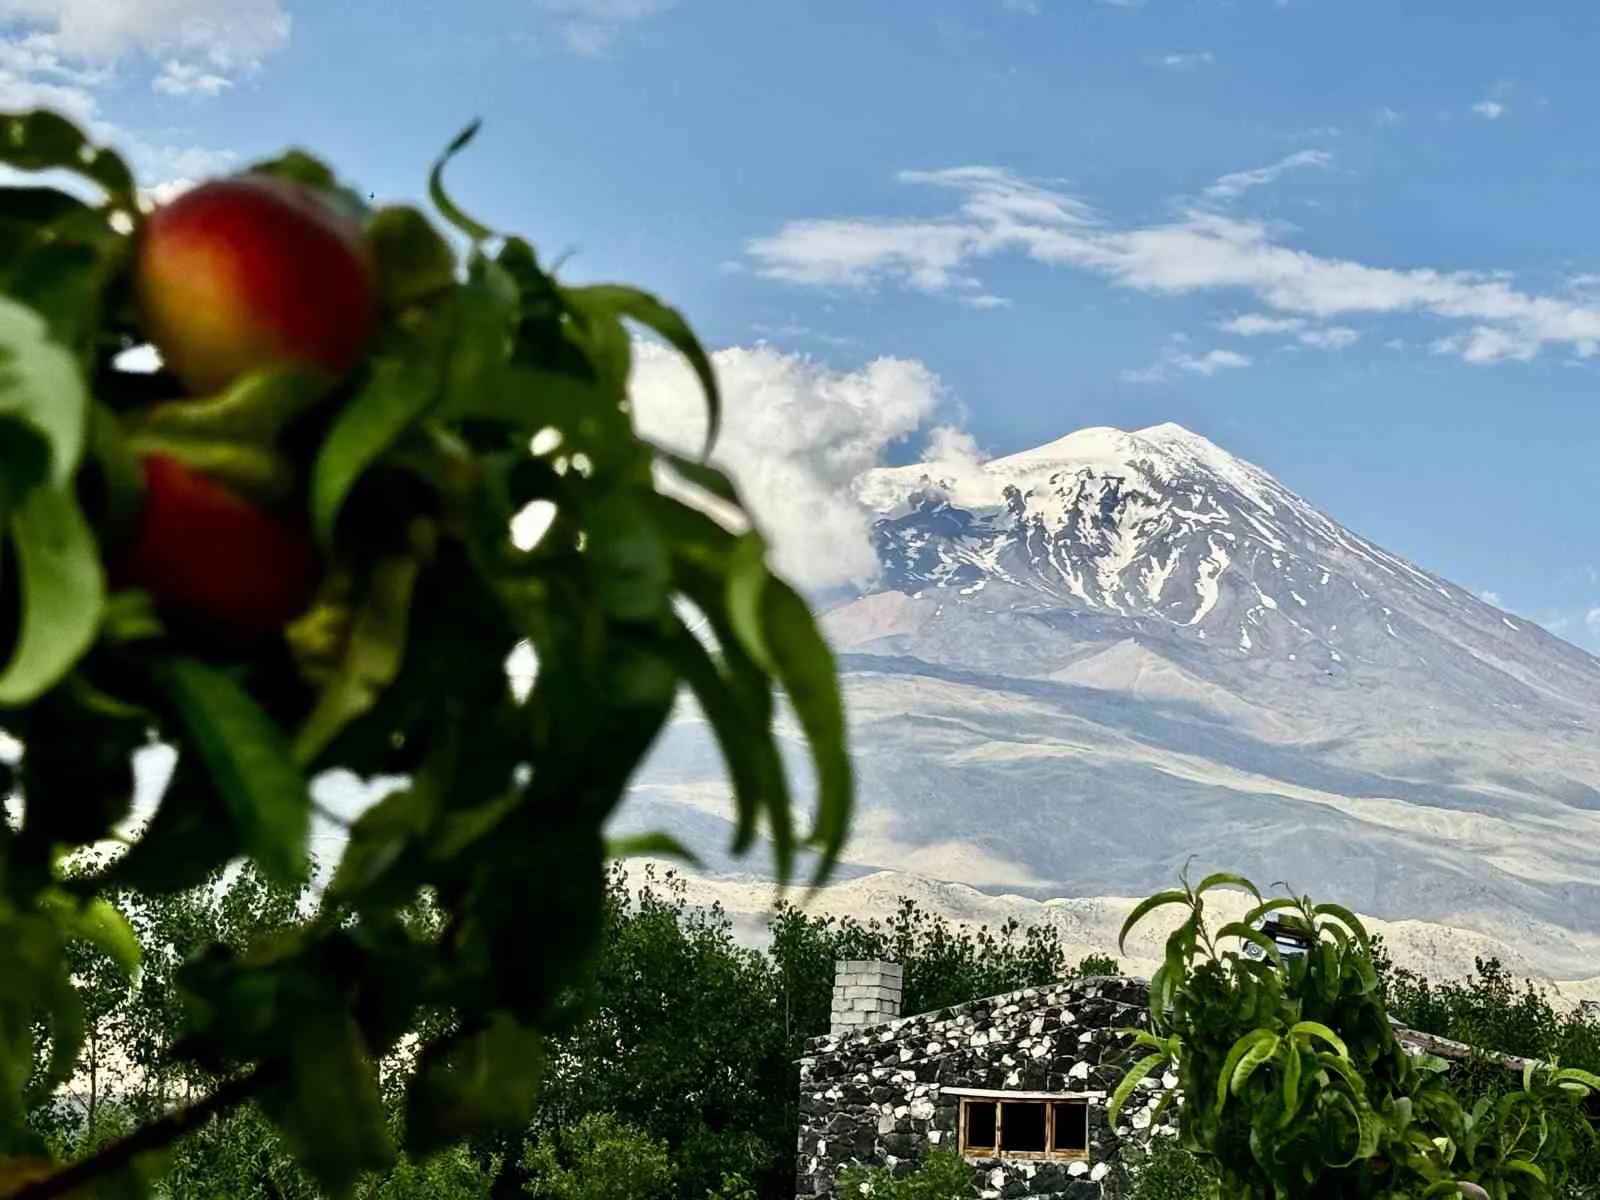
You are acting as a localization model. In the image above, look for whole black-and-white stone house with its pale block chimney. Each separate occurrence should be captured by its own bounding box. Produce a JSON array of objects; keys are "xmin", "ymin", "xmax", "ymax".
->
[{"xmin": 795, "ymin": 962, "xmax": 1178, "ymax": 1200}]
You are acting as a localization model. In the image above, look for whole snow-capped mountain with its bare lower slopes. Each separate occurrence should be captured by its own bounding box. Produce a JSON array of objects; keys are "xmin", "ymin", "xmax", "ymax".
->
[{"xmin": 634, "ymin": 424, "xmax": 1600, "ymax": 984}]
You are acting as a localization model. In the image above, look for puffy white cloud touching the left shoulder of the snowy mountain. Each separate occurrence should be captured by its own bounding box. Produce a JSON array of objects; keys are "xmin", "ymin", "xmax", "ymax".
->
[{"xmin": 632, "ymin": 344, "xmax": 947, "ymax": 587}]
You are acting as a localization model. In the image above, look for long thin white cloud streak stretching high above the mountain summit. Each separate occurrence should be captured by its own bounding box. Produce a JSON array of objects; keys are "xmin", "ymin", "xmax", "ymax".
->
[{"xmin": 747, "ymin": 163, "xmax": 1600, "ymax": 363}]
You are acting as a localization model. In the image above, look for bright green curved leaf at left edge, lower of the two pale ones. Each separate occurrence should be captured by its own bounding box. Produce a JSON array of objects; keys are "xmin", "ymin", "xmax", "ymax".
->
[{"xmin": 0, "ymin": 486, "xmax": 106, "ymax": 706}]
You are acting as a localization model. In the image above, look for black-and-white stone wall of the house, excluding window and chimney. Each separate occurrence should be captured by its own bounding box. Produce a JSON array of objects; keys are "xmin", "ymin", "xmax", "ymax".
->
[{"xmin": 795, "ymin": 978, "xmax": 1178, "ymax": 1200}]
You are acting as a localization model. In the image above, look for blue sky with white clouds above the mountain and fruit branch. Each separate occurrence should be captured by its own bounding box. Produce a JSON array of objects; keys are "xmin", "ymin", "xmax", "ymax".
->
[{"xmin": 9, "ymin": 0, "xmax": 1600, "ymax": 650}]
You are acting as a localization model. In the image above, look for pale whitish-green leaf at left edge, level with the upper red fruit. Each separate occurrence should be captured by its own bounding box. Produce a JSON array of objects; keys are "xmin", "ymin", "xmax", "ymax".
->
[{"xmin": 0, "ymin": 296, "xmax": 90, "ymax": 488}]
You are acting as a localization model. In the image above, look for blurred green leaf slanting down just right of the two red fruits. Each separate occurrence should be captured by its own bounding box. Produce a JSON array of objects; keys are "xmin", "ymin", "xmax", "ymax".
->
[{"xmin": 310, "ymin": 306, "xmax": 458, "ymax": 544}]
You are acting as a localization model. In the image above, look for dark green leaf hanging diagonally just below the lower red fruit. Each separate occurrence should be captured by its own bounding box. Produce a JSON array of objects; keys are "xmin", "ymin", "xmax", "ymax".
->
[{"xmin": 155, "ymin": 658, "xmax": 310, "ymax": 883}]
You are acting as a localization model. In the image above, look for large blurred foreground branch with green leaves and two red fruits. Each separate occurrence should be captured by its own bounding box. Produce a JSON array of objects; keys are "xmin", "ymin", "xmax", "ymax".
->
[{"xmin": 0, "ymin": 110, "xmax": 853, "ymax": 1195}]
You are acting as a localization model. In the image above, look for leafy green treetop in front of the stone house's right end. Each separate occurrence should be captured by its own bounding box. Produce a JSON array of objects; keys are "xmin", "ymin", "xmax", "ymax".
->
[{"xmin": 1109, "ymin": 874, "xmax": 1600, "ymax": 1200}]
